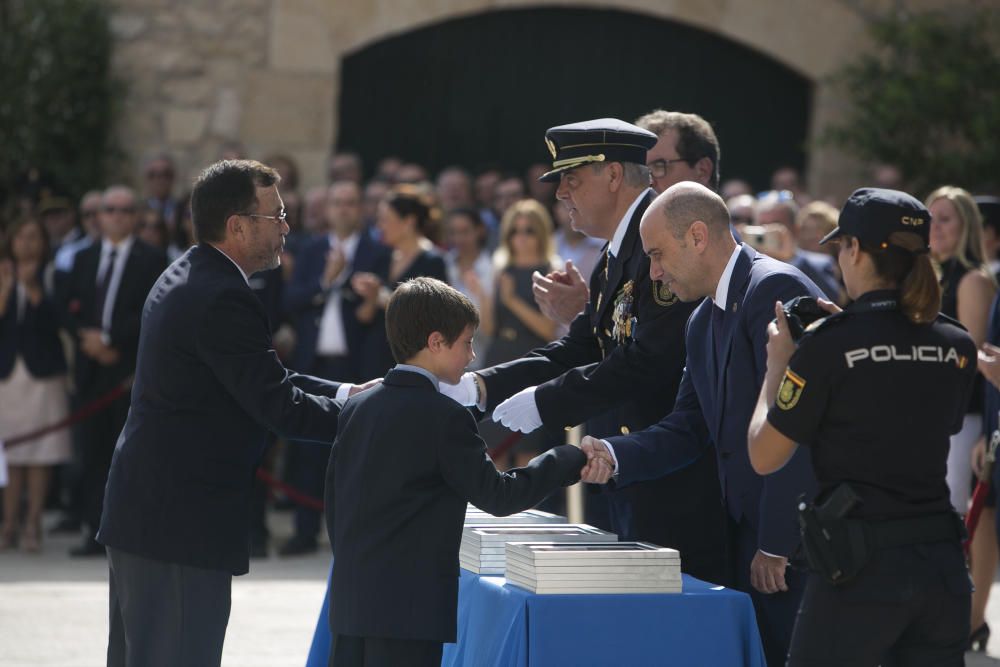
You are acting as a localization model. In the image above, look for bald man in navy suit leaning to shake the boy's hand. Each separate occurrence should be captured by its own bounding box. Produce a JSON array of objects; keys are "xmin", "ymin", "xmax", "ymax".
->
[{"xmin": 583, "ymin": 182, "xmax": 822, "ymax": 665}]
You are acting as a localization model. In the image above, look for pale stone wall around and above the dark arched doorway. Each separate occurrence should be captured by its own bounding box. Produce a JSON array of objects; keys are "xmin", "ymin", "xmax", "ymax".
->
[{"xmin": 113, "ymin": 0, "xmax": 936, "ymax": 197}]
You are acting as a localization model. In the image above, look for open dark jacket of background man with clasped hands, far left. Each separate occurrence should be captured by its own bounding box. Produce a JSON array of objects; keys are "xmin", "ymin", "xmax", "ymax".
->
[{"xmin": 65, "ymin": 239, "xmax": 167, "ymax": 398}]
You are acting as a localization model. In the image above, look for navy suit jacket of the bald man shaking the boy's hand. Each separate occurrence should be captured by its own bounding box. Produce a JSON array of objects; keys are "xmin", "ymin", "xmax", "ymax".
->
[{"xmin": 609, "ymin": 244, "xmax": 823, "ymax": 556}]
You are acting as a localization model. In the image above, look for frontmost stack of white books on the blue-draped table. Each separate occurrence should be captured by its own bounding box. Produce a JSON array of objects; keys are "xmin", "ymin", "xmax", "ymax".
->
[{"xmin": 505, "ymin": 541, "xmax": 681, "ymax": 594}]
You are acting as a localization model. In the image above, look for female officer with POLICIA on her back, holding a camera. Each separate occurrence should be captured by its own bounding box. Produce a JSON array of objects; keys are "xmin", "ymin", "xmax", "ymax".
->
[{"xmin": 749, "ymin": 188, "xmax": 976, "ymax": 666}]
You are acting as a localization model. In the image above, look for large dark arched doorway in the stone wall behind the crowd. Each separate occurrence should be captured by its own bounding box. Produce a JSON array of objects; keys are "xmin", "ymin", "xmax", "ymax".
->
[{"xmin": 337, "ymin": 8, "xmax": 812, "ymax": 188}]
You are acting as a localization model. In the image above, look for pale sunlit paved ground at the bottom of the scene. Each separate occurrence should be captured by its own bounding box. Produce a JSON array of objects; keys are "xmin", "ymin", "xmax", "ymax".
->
[{"xmin": 0, "ymin": 513, "xmax": 1000, "ymax": 667}]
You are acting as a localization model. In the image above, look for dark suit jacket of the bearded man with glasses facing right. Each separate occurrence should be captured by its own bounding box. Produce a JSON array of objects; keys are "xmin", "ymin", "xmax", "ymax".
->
[{"xmin": 97, "ymin": 245, "xmax": 340, "ymax": 574}]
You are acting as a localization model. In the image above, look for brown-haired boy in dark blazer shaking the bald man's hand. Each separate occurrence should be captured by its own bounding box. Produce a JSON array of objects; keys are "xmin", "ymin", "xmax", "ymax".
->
[{"xmin": 326, "ymin": 278, "xmax": 586, "ymax": 667}]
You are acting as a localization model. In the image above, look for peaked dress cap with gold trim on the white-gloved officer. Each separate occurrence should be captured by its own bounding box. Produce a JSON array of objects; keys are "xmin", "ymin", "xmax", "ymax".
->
[{"xmin": 538, "ymin": 118, "xmax": 657, "ymax": 181}]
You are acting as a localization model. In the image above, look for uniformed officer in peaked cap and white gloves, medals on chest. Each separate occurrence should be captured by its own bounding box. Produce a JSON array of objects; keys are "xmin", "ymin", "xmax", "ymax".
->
[{"xmin": 442, "ymin": 119, "xmax": 726, "ymax": 582}]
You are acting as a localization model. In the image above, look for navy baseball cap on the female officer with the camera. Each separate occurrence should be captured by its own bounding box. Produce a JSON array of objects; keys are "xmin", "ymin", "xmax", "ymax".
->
[{"xmin": 820, "ymin": 188, "xmax": 931, "ymax": 252}]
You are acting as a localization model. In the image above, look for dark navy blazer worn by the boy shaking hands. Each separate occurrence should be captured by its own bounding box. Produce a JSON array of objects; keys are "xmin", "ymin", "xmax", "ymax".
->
[{"xmin": 326, "ymin": 368, "xmax": 586, "ymax": 642}]
